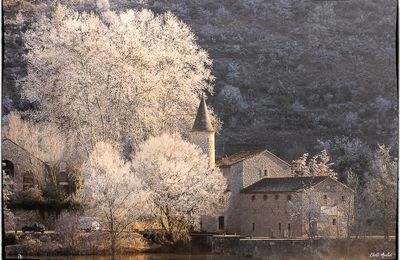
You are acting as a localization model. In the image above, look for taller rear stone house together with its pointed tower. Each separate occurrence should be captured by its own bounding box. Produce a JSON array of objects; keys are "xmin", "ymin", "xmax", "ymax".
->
[{"xmin": 190, "ymin": 97, "xmax": 290, "ymax": 233}]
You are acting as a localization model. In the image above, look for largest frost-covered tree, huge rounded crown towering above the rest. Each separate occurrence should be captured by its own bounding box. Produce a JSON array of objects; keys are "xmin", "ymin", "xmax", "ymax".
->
[{"xmin": 21, "ymin": 5, "xmax": 217, "ymax": 153}]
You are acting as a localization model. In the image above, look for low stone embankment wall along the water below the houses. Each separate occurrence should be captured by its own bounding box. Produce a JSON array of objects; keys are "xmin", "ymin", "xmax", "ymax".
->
[{"xmin": 211, "ymin": 236, "xmax": 396, "ymax": 260}]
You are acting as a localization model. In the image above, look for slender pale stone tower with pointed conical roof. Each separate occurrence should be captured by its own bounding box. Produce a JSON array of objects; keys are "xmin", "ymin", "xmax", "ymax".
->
[{"xmin": 190, "ymin": 96, "xmax": 215, "ymax": 168}]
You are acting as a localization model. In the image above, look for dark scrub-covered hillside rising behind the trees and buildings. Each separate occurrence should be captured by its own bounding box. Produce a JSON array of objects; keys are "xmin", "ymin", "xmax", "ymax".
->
[{"xmin": 3, "ymin": 0, "xmax": 398, "ymax": 160}]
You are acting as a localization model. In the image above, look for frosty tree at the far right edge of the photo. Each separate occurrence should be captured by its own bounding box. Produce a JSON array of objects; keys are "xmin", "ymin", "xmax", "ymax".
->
[{"xmin": 365, "ymin": 145, "xmax": 398, "ymax": 239}]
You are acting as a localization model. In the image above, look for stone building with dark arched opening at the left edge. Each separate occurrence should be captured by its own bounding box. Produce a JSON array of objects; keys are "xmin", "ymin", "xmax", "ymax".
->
[{"xmin": 1, "ymin": 139, "xmax": 46, "ymax": 192}]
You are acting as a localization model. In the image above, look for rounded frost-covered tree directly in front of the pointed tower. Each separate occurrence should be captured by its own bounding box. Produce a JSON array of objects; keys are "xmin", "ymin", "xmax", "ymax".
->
[{"xmin": 133, "ymin": 134, "xmax": 226, "ymax": 243}]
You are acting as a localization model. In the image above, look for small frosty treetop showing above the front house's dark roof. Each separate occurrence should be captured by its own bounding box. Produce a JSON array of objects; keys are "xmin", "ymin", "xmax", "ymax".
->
[{"xmin": 292, "ymin": 149, "xmax": 337, "ymax": 178}]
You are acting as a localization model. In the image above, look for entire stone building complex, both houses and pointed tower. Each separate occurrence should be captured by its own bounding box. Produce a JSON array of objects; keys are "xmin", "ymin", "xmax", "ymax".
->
[{"xmin": 190, "ymin": 97, "xmax": 354, "ymax": 237}]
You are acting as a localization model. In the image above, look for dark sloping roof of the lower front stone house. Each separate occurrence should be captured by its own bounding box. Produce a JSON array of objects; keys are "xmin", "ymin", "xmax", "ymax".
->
[{"xmin": 241, "ymin": 176, "xmax": 330, "ymax": 193}]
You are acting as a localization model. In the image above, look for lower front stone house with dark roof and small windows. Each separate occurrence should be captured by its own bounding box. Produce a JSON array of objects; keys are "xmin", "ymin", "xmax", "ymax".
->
[{"xmin": 240, "ymin": 176, "xmax": 354, "ymax": 238}]
